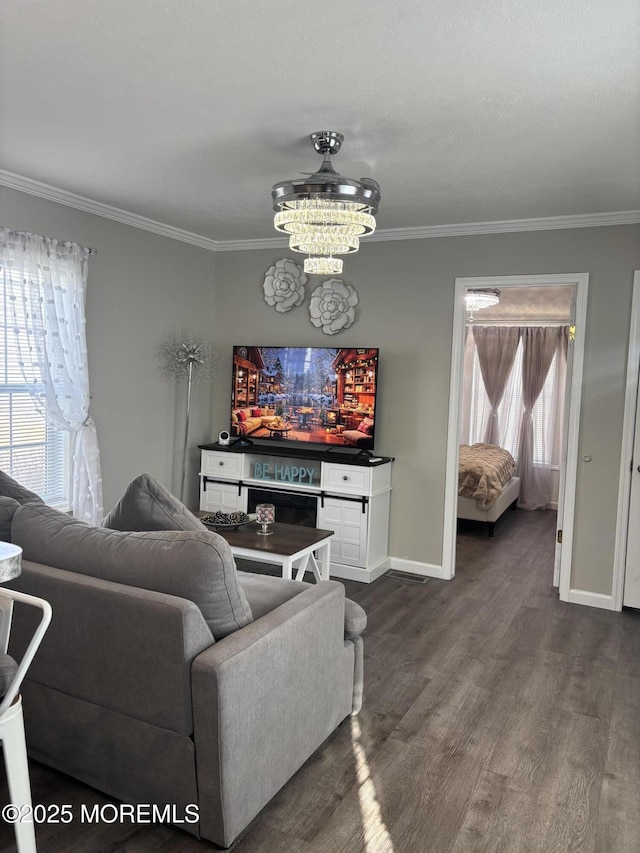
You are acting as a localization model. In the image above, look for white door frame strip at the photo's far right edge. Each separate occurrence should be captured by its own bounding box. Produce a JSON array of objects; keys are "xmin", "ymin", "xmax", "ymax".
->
[{"xmin": 611, "ymin": 270, "xmax": 640, "ymax": 610}]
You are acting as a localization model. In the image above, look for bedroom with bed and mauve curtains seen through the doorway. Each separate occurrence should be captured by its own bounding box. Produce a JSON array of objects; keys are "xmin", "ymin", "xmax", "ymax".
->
[{"xmin": 457, "ymin": 285, "xmax": 575, "ymax": 544}]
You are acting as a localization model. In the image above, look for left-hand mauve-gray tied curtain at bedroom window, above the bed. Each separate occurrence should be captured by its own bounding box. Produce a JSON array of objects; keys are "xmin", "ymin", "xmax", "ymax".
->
[{"xmin": 473, "ymin": 326, "xmax": 524, "ymax": 445}]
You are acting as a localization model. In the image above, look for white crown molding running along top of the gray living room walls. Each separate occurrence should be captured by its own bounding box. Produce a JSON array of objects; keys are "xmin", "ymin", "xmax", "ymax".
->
[{"xmin": 0, "ymin": 169, "xmax": 640, "ymax": 252}]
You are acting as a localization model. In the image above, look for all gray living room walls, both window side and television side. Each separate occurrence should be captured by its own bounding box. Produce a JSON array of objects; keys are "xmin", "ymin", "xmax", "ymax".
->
[{"xmin": 0, "ymin": 182, "xmax": 640, "ymax": 595}]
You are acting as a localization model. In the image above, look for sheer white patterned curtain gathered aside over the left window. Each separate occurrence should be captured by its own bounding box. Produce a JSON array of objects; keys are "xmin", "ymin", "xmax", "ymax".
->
[{"xmin": 0, "ymin": 228, "xmax": 103, "ymax": 524}]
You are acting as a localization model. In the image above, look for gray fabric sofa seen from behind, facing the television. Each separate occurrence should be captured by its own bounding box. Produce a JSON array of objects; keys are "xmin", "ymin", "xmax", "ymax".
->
[{"xmin": 0, "ymin": 472, "xmax": 366, "ymax": 847}]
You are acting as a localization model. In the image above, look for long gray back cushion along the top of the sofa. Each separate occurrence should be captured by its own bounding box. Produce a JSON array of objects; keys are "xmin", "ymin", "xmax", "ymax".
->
[{"xmin": 11, "ymin": 504, "xmax": 253, "ymax": 640}]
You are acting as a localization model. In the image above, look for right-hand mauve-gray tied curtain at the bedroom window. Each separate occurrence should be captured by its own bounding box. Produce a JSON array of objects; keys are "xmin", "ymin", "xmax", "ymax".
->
[{"xmin": 517, "ymin": 326, "xmax": 563, "ymax": 509}]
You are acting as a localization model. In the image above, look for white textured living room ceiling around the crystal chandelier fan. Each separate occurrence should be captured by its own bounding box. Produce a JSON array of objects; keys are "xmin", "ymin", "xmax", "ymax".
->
[{"xmin": 0, "ymin": 0, "xmax": 640, "ymax": 241}]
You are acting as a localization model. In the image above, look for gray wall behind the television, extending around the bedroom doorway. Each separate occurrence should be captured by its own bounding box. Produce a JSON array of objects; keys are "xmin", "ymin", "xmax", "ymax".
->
[{"xmin": 213, "ymin": 226, "xmax": 640, "ymax": 594}]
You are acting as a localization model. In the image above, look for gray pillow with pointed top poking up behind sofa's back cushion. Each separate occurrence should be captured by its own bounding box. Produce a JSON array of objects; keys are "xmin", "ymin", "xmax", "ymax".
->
[{"xmin": 102, "ymin": 474, "xmax": 206, "ymax": 530}]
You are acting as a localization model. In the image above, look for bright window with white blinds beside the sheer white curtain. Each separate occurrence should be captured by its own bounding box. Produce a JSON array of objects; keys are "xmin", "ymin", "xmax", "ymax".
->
[{"xmin": 0, "ymin": 266, "xmax": 71, "ymax": 510}]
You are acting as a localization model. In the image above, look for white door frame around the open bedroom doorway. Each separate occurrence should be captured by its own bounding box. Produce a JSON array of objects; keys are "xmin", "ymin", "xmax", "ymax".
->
[{"xmin": 441, "ymin": 273, "xmax": 589, "ymax": 601}]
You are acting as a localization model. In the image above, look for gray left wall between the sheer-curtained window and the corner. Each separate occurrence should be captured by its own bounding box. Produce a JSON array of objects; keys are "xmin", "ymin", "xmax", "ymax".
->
[{"xmin": 0, "ymin": 187, "xmax": 214, "ymax": 510}]
